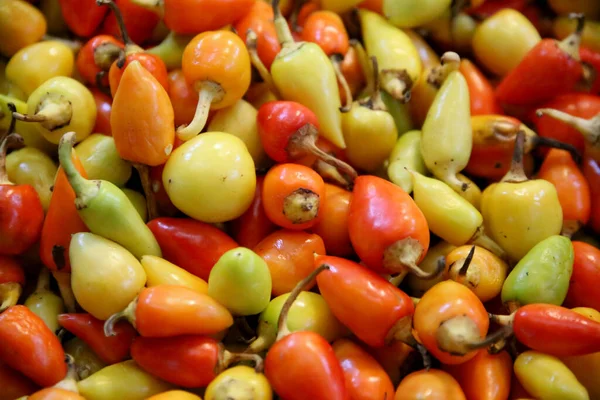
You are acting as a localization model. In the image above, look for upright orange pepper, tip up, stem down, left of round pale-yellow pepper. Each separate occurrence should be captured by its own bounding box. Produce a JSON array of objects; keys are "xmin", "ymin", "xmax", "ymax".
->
[{"xmin": 110, "ymin": 60, "xmax": 175, "ymax": 220}]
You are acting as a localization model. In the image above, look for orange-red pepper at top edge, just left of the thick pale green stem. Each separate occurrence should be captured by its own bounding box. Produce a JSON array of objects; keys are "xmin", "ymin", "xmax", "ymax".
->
[{"xmin": 234, "ymin": 1, "xmax": 281, "ymax": 70}]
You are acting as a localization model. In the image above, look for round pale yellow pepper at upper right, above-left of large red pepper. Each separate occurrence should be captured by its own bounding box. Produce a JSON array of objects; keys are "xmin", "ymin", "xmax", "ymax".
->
[{"xmin": 473, "ymin": 8, "xmax": 542, "ymax": 76}]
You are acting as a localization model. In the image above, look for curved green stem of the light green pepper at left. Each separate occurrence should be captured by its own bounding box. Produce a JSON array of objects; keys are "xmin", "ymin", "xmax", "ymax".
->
[{"xmin": 58, "ymin": 132, "xmax": 98, "ymax": 209}]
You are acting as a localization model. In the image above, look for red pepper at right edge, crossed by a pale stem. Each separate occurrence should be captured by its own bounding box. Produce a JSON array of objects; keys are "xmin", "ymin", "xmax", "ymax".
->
[{"xmin": 531, "ymin": 93, "xmax": 600, "ymax": 153}]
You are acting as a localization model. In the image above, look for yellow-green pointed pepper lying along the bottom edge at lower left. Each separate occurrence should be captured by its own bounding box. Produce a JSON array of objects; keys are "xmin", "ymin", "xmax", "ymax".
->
[{"xmin": 77, "ymin": 360, "xmax": 173, "ymax": 400}]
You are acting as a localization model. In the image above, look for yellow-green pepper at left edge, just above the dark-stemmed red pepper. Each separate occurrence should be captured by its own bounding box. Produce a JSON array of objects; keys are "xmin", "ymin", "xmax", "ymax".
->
[{"xmin": 6, "ymin": 147, "xmax": 57, "ymax": 211}]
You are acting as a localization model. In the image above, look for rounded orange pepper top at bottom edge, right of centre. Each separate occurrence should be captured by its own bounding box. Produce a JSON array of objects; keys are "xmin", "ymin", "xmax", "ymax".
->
[{"xmin": 394, "ymin": 369, "xmax": 467, "ymax": 400}]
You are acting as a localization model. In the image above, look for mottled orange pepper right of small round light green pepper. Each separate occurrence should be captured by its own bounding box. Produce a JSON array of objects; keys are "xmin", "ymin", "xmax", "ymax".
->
[{"xmin": 254, "ymin": 229, "xmax": 325, "ymax": 296}]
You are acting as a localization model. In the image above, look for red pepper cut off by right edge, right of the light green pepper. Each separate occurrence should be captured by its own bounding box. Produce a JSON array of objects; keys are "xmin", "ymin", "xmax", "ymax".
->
[{"xmin": 565, "ymin": 241, "xmax": 600, "ymax": 310}]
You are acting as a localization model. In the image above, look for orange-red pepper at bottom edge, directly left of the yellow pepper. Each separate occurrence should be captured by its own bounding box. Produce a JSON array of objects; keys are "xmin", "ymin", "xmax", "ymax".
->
[{"xmin": 442, "ymin": 349, "xmax": 513, "ymax": 400}]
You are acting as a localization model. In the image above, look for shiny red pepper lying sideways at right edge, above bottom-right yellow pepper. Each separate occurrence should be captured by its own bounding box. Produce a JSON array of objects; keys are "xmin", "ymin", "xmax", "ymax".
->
[{"xmin": 512, "ymin": 304, "xmax": 600, "ymax": 357}]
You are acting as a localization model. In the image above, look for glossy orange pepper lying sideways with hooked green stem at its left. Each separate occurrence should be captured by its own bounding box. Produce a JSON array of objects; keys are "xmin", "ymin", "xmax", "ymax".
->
[{"xmin": 104, "ymin": 285, "xmax": 233, "ymax": 338}]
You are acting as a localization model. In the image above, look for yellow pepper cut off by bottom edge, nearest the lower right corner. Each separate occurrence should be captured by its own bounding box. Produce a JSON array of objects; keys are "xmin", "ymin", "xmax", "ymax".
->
[{"xmin": 514, "ymin": 351, "xmax": 590, "ymax": 400}]
